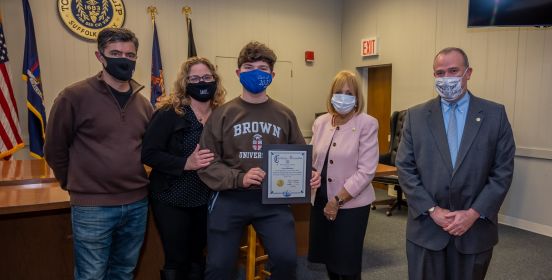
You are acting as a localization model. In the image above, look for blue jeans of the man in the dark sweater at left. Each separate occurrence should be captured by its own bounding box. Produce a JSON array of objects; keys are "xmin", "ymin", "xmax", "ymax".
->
[{"xmin": 71, "ymin": 198, "xmax": 148, "ymax": 280}]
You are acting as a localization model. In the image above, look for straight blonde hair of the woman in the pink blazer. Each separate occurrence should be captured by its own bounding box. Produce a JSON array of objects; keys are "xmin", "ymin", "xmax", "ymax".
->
[{"xmin": 326, "ymin": 70, "xmax": 364, "ymax": 115}]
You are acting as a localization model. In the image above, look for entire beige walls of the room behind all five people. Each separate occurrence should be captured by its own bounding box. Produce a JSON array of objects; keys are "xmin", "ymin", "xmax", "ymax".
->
[{"xmin": 4, "ymin": 0, "xmax": 552, "ymax": 235}]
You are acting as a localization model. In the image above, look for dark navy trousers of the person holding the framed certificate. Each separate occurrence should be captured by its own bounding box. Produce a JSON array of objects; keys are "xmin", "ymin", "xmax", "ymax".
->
[{"xmin": 205, "ymin": 190, "xmax": 297, "ymax": 280}]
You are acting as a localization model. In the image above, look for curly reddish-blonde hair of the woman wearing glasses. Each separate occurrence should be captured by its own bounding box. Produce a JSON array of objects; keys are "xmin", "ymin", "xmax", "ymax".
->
[{"xmin": 157, "ymin": 56, "xmax": 226, "ymax": 116}]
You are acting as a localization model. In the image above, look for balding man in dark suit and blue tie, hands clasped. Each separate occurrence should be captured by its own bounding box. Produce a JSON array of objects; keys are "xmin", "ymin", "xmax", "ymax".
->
[{"xmin": 396, "ymin": 48, "xmax": 515, "ymax": 280}]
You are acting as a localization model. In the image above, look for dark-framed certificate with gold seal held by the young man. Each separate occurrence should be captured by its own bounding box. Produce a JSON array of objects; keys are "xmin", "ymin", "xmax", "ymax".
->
[{"xmin": 262, "ymin": 144, "xmax": 312, "ymax": 204}]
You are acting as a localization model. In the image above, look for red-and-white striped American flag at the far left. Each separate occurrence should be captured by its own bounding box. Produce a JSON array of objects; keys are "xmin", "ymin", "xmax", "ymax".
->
[{"xmin": 0, "ymin": 14, "xmax": 25, "ymax": 159}]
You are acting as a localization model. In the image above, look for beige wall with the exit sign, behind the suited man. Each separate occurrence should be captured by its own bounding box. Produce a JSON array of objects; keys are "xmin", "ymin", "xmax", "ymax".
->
[{"xmin": 342, "ymin": 0, "xmax": 552, "ymax": 236}]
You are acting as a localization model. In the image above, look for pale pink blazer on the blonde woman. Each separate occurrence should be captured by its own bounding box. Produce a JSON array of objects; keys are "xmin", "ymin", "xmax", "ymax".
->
[{"xmin": 311, "ymin": 113, "xmax": 379, "ymax": 208}]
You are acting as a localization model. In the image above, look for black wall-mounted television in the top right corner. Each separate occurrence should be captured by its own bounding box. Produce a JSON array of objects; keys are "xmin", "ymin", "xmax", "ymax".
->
[{"xmin": 468, "ymin": 0, "xmax": 552, "ymax": 27}]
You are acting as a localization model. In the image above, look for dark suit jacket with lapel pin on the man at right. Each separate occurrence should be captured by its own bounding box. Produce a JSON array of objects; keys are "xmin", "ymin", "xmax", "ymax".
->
[{"xmin": 395, "ymin": 93, "xmax": 515, "ymax": 254}]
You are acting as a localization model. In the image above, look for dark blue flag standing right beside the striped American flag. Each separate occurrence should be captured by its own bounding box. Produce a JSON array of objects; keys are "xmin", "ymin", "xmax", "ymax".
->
[{"xmin": 22, "ymin": 0, "xmax": 46, "ymax": 158}]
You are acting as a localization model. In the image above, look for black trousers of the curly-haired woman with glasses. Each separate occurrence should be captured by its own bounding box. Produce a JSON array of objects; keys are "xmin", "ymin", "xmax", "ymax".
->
[{"xmin": 150, "ymin": 199, "xmax": 207, "ymax": 275}]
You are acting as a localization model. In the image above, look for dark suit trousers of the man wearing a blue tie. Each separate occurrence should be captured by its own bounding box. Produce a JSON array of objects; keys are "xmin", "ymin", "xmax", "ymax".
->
[{"xmin": 406, "ymin": 238, "xmax": 493, "ymax": 280}]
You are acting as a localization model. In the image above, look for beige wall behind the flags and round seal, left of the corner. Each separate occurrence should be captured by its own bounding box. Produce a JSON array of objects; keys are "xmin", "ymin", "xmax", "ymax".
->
[{"xmin": 0, "ymin": 0, "xmax": 341, "ymax": 158}]
